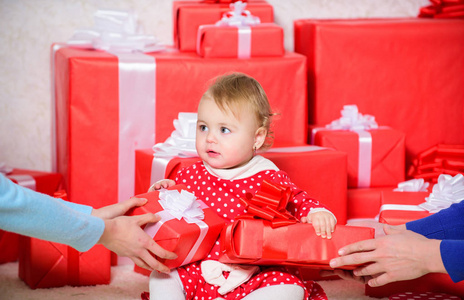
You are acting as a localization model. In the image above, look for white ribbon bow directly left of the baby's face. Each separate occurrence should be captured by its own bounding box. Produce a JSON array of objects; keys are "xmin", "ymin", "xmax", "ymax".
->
[{"xmin": 153, "ymin": 113, "xmax": 198, "ymax": 157}]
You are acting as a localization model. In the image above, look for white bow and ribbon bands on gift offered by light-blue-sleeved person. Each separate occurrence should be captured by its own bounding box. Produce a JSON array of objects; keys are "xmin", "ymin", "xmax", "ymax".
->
[{"xmin": 144, "ymin": 190, "xmax": 209, "ymax": 265}]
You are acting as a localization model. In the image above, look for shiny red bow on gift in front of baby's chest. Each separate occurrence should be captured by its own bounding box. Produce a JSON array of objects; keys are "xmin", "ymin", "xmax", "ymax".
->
[{"xmin": 237, "ymin": 180, "xmax": 297, "ymax": 228}]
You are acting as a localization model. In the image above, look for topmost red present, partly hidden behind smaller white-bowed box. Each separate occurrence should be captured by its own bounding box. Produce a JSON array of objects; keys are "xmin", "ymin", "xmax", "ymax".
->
[{"xmin": 173, "ymin": 0, "xmax": 274, "ymax": 52}]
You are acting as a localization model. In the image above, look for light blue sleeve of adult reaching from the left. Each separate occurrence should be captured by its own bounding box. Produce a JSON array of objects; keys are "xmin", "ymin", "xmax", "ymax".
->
[{"xmin": 0, "ymin": 174, "xmax": 105, "ymax": 251}]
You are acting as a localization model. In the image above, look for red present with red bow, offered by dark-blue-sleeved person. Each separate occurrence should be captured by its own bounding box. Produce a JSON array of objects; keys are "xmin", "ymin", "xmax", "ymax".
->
[{"xmin": 219, "ymin": 181, "xmax": 374, "ymax": 269}]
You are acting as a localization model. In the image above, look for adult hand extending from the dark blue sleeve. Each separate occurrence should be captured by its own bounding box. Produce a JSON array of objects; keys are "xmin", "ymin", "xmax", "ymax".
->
[{"xmin": 330, "ymin": 225, "xmax": 446, "ymax": 287}]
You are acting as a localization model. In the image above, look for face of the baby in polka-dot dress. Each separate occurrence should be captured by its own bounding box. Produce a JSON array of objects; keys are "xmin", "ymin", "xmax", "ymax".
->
[{"xmin": 196, "ymin": 97, "xmax": 258, "ymax": 169}]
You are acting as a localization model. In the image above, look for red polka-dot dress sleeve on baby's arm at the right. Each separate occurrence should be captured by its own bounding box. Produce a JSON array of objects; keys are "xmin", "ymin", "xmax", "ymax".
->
[{"xmin": 274, "ymin": 171, "xmax": 327, "ymax": 220}]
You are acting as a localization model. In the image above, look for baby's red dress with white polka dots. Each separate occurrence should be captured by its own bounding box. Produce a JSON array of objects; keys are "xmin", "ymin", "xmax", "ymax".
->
[{"xmin": 176, "ymin": 161, "xmax": 327, "ymax": 300}]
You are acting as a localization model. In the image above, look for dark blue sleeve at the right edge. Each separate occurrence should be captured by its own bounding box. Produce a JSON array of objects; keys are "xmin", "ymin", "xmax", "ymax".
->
[{"xmin": 406, "ymin": 201, "xmax": 464, "ymax": 282}]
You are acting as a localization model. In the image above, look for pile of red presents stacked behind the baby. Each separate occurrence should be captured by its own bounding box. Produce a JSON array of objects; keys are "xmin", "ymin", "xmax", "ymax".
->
[{"xmin": 2, "ymin": 0, "xmax": 464, "ymax": 297}]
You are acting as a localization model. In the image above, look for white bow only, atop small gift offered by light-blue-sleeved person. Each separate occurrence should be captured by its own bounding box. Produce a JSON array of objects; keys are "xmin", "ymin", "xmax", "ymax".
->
[{"xmin": 159, "ymin": 190, "xmax": 205, "ymax": 223}]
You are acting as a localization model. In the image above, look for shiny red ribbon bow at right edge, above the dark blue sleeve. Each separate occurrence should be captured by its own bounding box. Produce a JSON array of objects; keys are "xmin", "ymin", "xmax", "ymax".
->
[{"xmin": 407, "ymin": 144, "xmax": 464, "ymax": 183}]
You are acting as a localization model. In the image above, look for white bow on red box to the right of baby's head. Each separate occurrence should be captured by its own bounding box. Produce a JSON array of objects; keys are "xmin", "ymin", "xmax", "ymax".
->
[{"xmin": 326, "ymin": 105, "xmax": 379, "ymax": 131}]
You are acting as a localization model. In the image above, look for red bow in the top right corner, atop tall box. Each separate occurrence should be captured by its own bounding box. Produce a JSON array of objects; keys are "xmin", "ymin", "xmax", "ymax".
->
[{"xmin": 419, "ymin": 0, "xmax": 464, "ymax": 18}]
